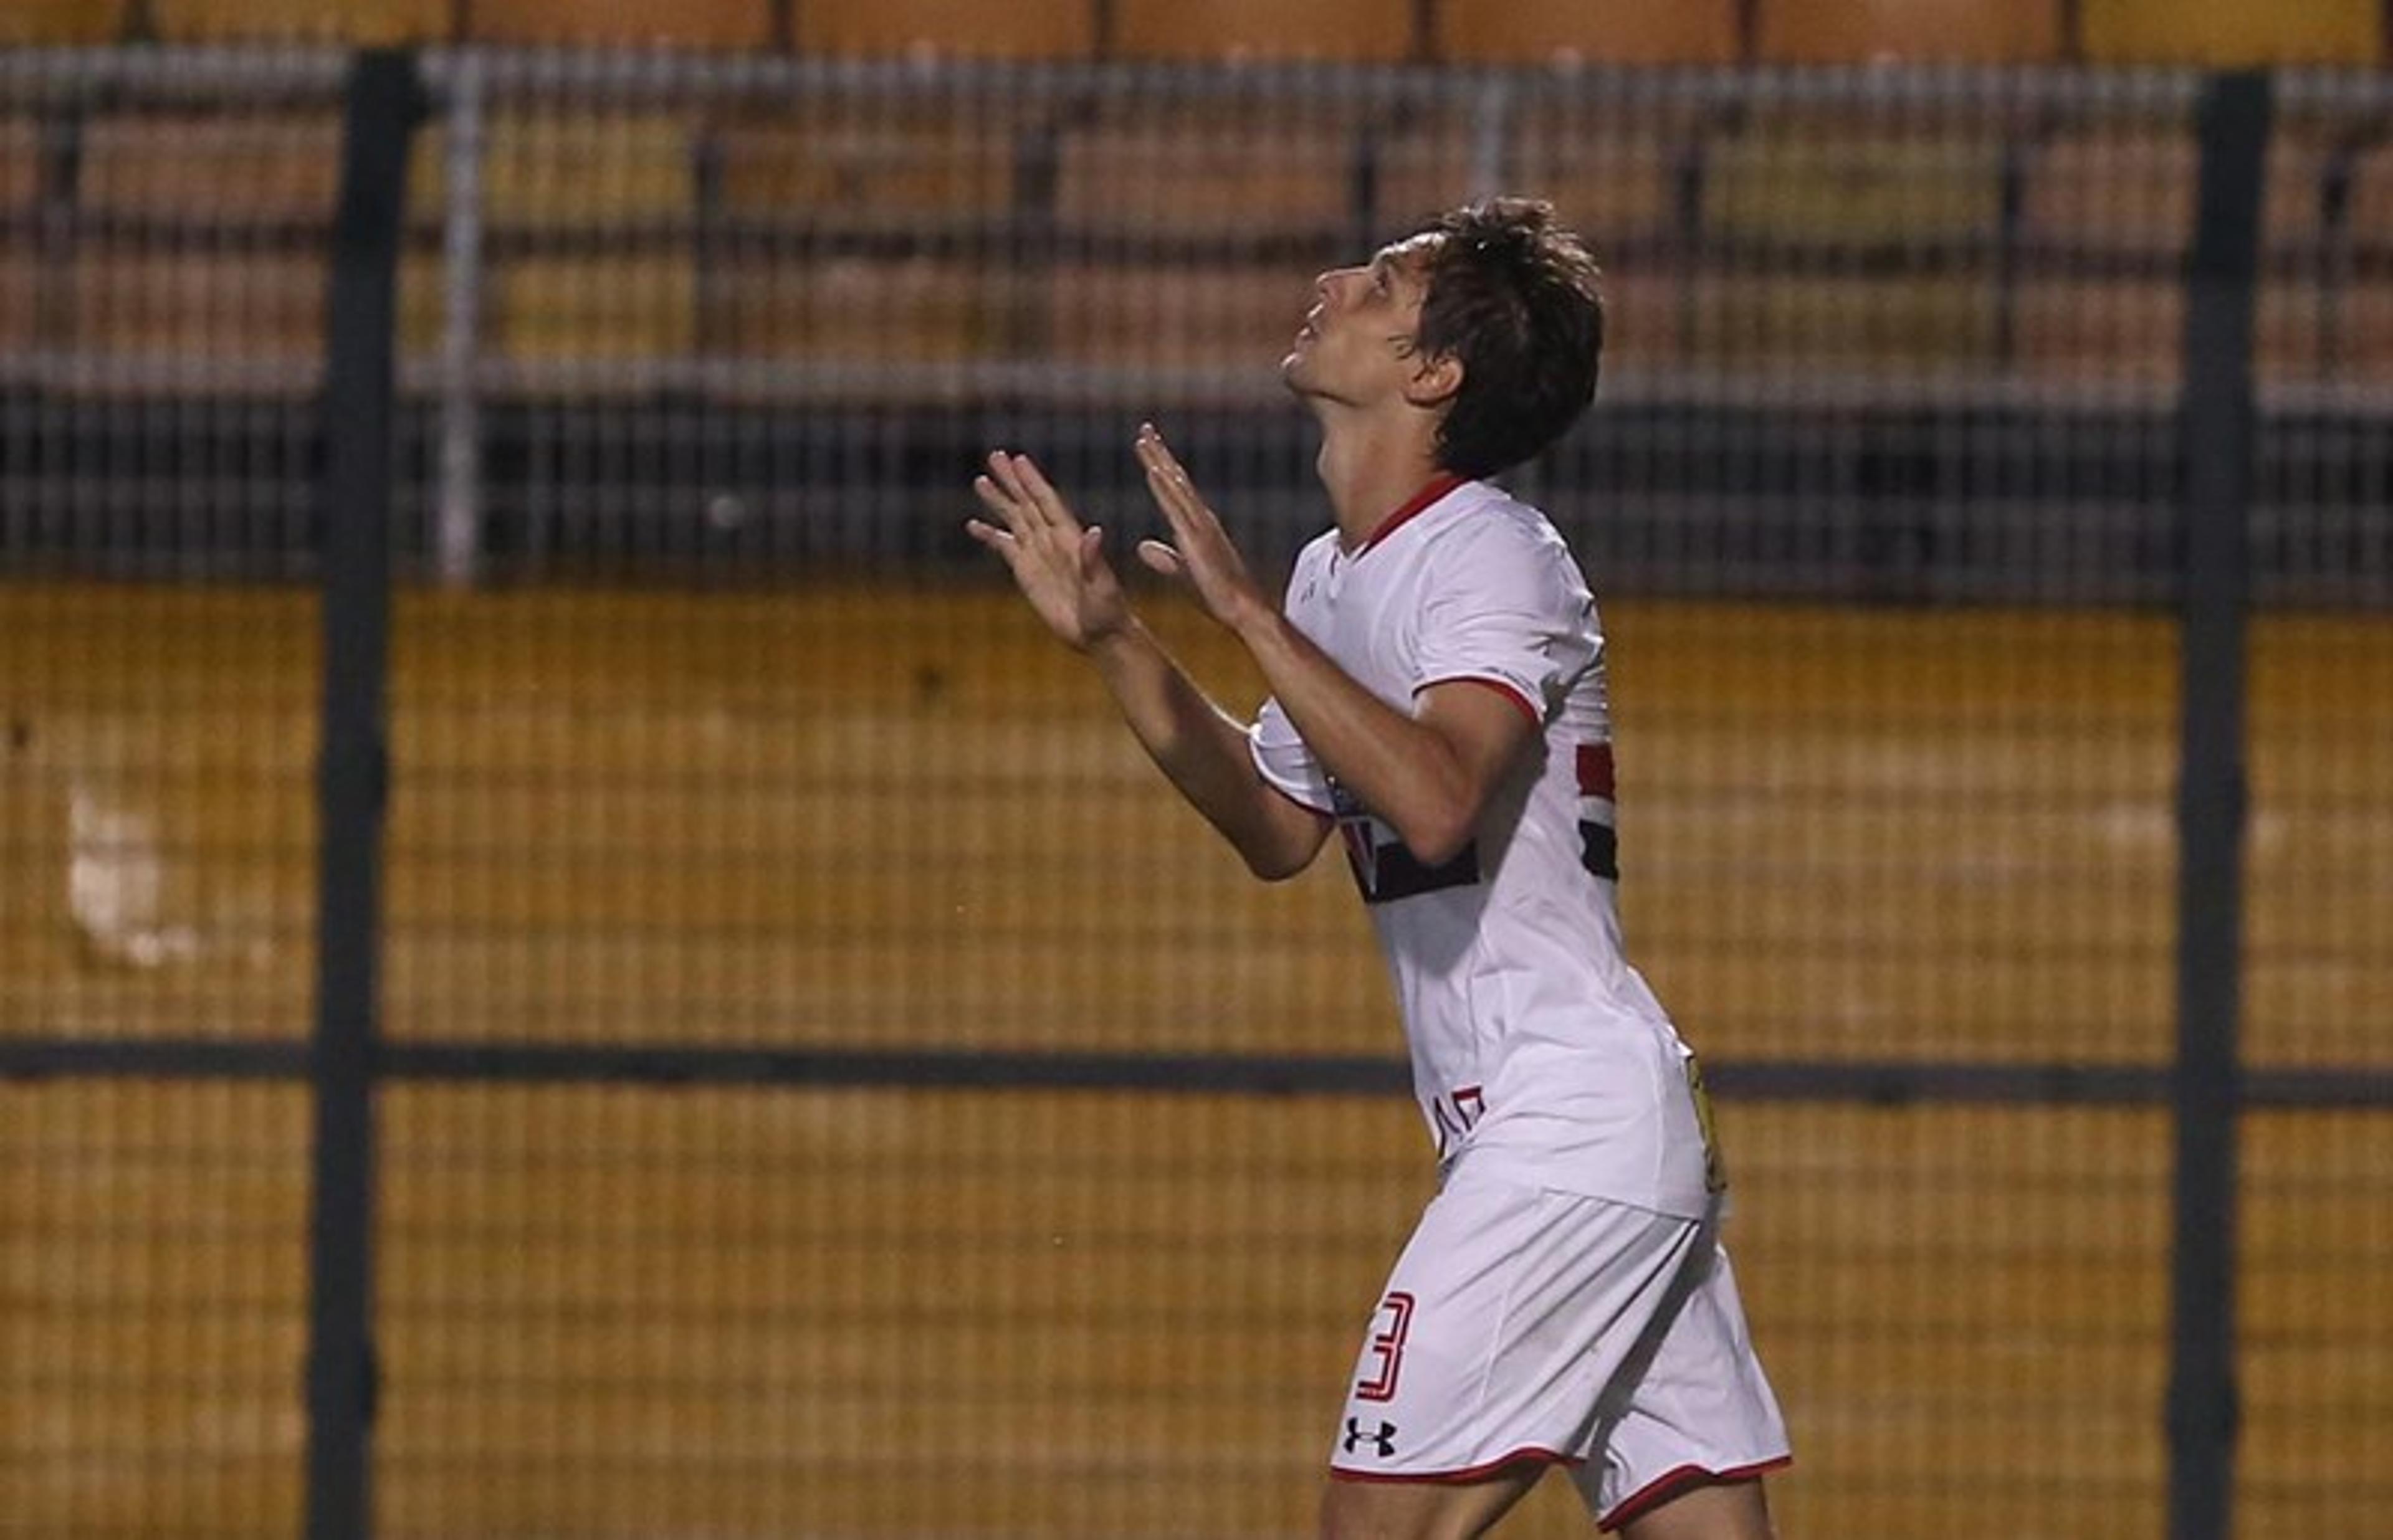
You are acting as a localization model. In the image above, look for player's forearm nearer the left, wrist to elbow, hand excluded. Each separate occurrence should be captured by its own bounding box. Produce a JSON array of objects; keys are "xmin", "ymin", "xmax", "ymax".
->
[{"xmin": 1089, "ymin": 619, "xmax": 1321, "ymax": 878}]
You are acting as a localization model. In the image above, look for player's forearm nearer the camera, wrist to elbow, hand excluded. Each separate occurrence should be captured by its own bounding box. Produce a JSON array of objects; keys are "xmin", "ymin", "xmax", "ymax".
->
[{"xmin": 1237, "ymin": 612, "xmax": 1481, "ymax": 863}]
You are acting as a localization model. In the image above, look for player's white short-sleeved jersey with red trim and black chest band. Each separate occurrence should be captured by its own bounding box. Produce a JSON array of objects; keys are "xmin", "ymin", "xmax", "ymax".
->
[{"xmin": 1249, "ymin": 478, "xmax": 1718, "ymax": 1217}]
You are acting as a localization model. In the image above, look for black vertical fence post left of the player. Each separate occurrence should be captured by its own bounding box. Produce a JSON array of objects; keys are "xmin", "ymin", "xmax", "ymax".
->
[{"xmin": 307, "ymin": 50, "xmax": 426, "ymax": 1540}]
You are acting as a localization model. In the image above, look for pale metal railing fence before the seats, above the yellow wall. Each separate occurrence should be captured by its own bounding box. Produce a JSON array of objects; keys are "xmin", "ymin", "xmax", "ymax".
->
[{"xmin": 7, "ymin": 50, "xmax": 2393, "ymax": 605}]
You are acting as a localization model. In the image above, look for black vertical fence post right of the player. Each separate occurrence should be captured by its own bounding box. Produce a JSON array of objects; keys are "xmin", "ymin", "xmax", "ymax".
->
[{"xmin": 2168, "ymin": 72, "xmax": 2271, "ymax": 1540}]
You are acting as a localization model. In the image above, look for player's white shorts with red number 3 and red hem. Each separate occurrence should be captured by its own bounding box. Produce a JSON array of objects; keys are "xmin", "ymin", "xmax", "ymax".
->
[{"xmin": 1330, "ymin": 1164, "xmax": 1790, "ymax": 1528}]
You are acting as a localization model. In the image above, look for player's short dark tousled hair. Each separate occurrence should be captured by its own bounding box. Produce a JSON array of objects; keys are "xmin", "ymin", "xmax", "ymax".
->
[{"xmin": 1412, "ymin": 199, "xmax": 1603, "ymax": 478}]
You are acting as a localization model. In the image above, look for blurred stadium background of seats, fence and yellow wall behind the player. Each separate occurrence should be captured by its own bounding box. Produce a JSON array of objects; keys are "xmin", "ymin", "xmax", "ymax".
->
[{"xmin": 0, "ymin": 0, "xmax": 2393, "ymax": 1540}]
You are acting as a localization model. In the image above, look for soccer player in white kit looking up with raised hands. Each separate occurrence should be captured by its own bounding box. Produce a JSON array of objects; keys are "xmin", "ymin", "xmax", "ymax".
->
[{"xmin": 967, "ymin": 199, "xmax": 1787, "ymax": 1540}]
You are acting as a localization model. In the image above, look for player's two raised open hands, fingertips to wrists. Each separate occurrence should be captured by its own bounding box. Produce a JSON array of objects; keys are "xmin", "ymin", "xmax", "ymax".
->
[{"xmin": 965, "ymin": 423, "xmax": 1271, "ymax": 653}]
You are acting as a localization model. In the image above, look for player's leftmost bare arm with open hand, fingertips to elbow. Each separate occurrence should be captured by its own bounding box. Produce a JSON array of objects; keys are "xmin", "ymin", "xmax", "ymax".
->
[{"xmin": 965, "ymin": 450, "xmax": 1330, "ymax": 880}]
